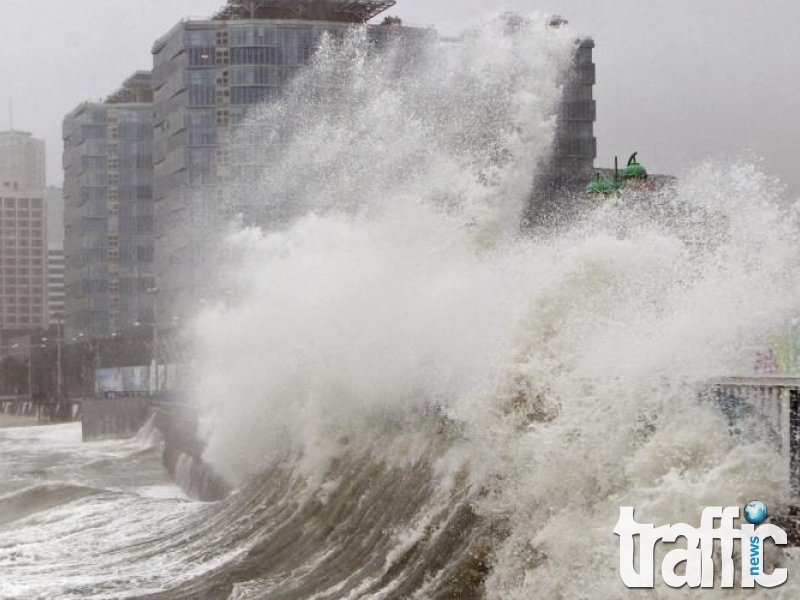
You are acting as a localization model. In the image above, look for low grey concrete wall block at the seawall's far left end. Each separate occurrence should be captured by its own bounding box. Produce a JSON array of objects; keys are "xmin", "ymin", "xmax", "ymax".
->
[{"xmin": 82, "ymin": 397, "xmax": 150, "ymax": 442}]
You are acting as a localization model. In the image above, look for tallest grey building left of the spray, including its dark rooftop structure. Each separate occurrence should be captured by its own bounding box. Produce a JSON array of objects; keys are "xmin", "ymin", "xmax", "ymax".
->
[{"xmin": 153, "ymin": 0, "xmax": 422, "ymax": 323}]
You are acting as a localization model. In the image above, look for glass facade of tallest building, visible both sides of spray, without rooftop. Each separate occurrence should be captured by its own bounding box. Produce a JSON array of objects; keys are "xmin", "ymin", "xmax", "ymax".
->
[{"xmin": 153, "ymin": 19, "xmax": 596, "ymax": 323}]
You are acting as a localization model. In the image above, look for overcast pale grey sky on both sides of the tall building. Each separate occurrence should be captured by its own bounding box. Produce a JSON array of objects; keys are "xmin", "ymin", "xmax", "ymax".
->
[{"xmin": 0, "ymin": 0, "xmax": 800, "ymax": 196}]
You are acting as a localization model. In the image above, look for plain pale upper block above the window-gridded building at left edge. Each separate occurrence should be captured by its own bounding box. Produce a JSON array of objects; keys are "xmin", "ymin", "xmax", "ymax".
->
[{"xmin": 0, "ymin": 130, "xmax": 45, "ymax": 192}]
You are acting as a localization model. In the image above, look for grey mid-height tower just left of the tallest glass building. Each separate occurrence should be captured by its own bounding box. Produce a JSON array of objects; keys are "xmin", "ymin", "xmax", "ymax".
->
[{"xmin": 64, "ymin": 72, "xmax": 154, "ymax": 336}]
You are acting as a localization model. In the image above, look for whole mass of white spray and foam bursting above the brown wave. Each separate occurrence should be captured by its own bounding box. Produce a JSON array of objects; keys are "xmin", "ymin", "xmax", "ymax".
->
[{"xmin": 184, "ymin": 16, "xmax": 800, "ymax": 598}]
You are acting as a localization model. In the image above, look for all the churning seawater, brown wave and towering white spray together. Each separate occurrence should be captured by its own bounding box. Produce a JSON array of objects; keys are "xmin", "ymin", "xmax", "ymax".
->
[{"xmin": 0, "ymin": 20, "xmax": 800, "ymax": 599}]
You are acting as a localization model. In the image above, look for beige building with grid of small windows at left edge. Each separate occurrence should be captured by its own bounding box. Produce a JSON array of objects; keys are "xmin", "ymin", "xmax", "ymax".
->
[{"xmin": 0, "ymin": 180, "xmax": 47, "ymax": 337}]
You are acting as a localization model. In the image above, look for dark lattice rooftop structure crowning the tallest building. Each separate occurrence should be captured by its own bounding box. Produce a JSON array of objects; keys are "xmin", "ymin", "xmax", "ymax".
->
[{"xmin": 214, "ymin": 0, "xmax": 396, "ymax": 23}]
